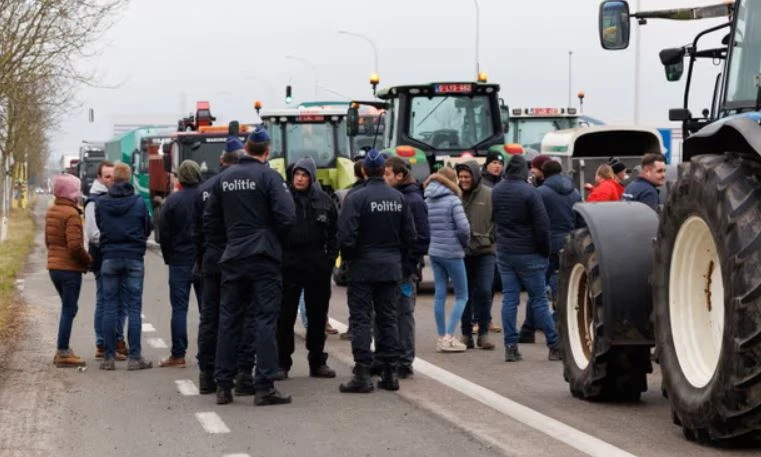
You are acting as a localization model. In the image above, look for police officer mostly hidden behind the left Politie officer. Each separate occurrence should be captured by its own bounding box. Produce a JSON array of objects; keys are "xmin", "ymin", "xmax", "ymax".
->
[{"xmin": 193, "ymin": 136, "xmax": 254, "ymax": 396}]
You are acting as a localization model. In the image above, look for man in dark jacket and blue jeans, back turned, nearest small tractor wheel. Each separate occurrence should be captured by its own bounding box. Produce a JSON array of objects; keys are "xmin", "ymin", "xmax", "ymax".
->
[{"xmin": 492, "ymin": 155, "xmax": 560, "ymax": 362}]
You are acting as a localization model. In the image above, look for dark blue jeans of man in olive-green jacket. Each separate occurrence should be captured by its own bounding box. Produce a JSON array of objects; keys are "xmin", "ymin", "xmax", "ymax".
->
[{"xmin": 461, "ymin": 254, "xmax": 497, "ymax": 336}]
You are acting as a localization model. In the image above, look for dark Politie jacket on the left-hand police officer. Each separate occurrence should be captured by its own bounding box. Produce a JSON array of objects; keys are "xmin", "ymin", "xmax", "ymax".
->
[{"xmin": 204, "ymin": 157, "xmax": 296, "ymax": 264}]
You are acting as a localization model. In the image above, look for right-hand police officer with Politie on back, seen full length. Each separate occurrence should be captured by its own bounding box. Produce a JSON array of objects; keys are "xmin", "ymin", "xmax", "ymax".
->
[{"xmin": 338, "ymin": 149, "xmax": 417, "ymax": 393}]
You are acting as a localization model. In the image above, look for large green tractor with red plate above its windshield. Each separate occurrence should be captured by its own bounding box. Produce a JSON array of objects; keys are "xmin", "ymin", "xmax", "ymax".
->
[{"xmin": 346, "ymin": 82, "xmax": 508, "ymax": 180}]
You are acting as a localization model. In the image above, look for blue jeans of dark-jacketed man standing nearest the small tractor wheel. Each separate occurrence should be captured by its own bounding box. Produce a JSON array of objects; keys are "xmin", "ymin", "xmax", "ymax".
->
[{"xmin": 497, "ymin": 253, "xmax": 558, "ymax": 348}]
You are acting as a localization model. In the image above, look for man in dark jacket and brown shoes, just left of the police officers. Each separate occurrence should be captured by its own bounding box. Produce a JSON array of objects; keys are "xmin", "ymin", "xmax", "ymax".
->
[{"xmin": 159, "ymin": 160, "xmax": 201, "ymax": 368}]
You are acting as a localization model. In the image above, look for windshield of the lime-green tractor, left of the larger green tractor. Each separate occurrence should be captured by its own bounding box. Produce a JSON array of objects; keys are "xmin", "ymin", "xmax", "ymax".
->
[{"xmin": 270, "ymin": 120, "xmax": 349, "ymax": 168}]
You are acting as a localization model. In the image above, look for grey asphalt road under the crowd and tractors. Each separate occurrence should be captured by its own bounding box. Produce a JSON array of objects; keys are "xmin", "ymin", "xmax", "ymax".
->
[{"xmin": 0, "ymin": 197, "xmax": 759, "ymax": 457}]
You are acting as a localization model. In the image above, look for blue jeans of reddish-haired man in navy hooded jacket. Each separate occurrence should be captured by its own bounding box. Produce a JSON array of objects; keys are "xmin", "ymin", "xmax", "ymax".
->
[{"xmin": 100, "ymin": 259, "xmax": 145, "ymax": 359}]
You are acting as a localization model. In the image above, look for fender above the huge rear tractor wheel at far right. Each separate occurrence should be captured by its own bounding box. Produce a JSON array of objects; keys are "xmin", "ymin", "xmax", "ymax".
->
[{"xmin": 682, "ymin": 117, "xmax": 761, "ymax": 162}]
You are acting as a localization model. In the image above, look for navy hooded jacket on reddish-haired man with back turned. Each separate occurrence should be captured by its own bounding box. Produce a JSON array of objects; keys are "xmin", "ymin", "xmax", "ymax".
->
[{"xmin": 95, "ymin": 182, "xmax": 151, "ymax": 260}]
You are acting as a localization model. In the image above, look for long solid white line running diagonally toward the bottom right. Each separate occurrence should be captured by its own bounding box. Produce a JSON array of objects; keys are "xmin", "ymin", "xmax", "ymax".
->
[{"xmin": 330, "ymin": 318, "xmax": 634, "ymax": 457}]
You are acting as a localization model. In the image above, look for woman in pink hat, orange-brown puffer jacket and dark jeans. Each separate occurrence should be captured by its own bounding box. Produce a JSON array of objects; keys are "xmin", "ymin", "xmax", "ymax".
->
[{"xmin": 45, "ymin": 174, "xmax": 92, "ymax": 368}]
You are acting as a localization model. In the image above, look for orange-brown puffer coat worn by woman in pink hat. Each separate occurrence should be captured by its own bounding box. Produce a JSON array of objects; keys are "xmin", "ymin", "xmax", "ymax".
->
[{"xmin": 45, "ymin": 198, "xmax": 91, "ymax": 273}]
